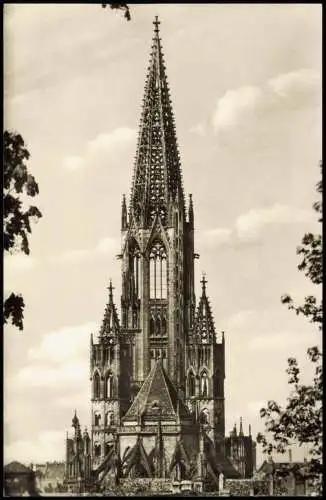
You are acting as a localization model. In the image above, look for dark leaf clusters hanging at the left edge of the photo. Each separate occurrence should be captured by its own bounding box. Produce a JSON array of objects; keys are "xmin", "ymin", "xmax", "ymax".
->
[{"xmin": 3, "ymin": 131, "xmax": 42, "ymax": 330}]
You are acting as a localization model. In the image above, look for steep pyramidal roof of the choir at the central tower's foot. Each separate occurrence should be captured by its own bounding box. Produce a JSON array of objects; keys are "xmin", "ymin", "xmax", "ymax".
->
[{"xmin": 124, "ymin": 359, "xmax": 189, "ymax": 420}]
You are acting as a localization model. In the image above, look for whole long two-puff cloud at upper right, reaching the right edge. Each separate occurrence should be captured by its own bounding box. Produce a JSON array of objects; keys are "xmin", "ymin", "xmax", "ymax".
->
[{"xmin": 212, "ymin": 68, "xmax": 321, "ymax": 134}]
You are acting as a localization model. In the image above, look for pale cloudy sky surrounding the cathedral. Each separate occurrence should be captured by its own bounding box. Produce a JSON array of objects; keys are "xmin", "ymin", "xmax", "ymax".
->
[{"xmin": 4, "ymin": 3, "xmax": 322, "ymax": 463}]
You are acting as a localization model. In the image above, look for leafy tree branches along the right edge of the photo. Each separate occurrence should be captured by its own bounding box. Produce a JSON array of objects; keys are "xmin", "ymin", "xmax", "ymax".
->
[{"xmin": 257, "ymin": 165, "xmax": 323, "ymax": 488}]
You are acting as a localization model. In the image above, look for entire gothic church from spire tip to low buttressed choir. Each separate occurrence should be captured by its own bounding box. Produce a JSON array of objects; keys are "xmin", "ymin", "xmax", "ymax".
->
[{"xmin": 65, "ymin": 19, "xmax": 255, "ymax": 491}]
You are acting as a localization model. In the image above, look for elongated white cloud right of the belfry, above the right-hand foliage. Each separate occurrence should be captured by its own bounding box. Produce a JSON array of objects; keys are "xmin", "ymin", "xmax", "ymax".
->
[{"xmin": 236, "ymin": 203, "xmax": 312, "ymax": 238}]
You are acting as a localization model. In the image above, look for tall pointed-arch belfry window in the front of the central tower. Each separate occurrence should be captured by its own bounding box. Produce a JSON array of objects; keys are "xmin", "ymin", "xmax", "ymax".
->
[{"xmin": 149, "ymin": 242, "xmax": 167, "ymax": 299}]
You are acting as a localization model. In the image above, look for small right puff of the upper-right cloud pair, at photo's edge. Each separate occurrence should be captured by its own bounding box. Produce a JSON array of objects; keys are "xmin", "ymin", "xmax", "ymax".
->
[{"xmin": 268, "ymin": 69, "xmax": 320, "ymax": 97}]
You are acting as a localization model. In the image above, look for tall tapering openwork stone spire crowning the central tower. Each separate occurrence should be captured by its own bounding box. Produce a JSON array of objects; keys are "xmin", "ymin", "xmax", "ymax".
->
[{"xmin": 130, "ymin": 17, "xmax": 184, "ymax": 225}]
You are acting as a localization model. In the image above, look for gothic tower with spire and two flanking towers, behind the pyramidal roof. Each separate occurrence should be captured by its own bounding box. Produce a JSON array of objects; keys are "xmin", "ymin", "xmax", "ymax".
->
[{"xmin": 90, "ymin": 15, "xmax": 225, "ymax": 476}]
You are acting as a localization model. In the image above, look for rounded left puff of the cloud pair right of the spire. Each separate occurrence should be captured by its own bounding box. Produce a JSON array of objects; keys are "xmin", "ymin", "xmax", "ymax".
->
[{"xmin": 212, "ymin": 86, "xmax": 263, "ymax": 132}]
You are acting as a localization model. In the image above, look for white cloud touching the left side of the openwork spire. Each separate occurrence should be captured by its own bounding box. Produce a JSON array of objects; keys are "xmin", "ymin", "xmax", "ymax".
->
[{"xmin": 62, "ymin": 127, "xmax": 136, "ymax": 172}]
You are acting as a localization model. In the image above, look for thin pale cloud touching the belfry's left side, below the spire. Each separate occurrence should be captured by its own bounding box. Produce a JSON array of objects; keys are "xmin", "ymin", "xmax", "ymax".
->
[{"xmin": 54, "ymin": 237, "xmax": 120, "ymax": 264}]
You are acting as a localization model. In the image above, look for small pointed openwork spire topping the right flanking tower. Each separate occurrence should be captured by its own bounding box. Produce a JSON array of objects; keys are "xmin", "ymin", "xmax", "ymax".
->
[{"xmin": 194, "ymin": 273, "xmax": 216, "ymax": 344}]
